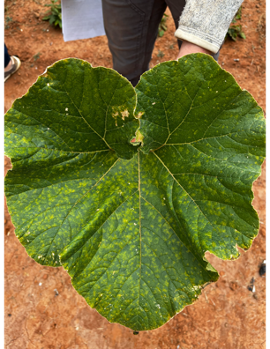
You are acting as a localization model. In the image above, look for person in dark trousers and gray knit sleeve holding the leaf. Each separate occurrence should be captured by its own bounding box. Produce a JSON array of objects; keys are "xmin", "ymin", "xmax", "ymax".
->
[{"xmin": 102, "ymin": 0, "xmax": 243, "ymax": 86}]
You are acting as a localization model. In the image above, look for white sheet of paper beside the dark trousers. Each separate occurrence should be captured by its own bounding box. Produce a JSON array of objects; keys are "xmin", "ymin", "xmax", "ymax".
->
[{"xmin": 61, "ymin": 0, "xmax": 105, "ymax": 41}]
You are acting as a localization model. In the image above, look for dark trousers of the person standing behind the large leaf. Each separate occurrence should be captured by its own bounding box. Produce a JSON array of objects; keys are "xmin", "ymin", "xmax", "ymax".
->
[{"xmin": 102, "ymin": 0, "xmax": 219, "ymax": 86}]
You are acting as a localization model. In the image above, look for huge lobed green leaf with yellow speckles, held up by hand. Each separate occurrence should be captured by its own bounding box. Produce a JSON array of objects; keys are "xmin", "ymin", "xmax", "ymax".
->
[{"xmin": 4, "ymin": 54, "xmax": 266, "ymax": 332}]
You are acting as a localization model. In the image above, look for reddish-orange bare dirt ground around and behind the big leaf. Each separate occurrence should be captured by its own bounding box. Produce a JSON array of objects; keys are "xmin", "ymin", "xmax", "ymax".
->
[{"xmin": 3, "ymin": 0, "xmax": 267, "ymax": 349}]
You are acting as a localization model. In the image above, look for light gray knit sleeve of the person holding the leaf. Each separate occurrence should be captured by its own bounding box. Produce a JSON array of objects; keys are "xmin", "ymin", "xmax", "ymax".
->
[{"xmin": 175, "ymin": 0, "xmax": 243, "ymax": 53}]
